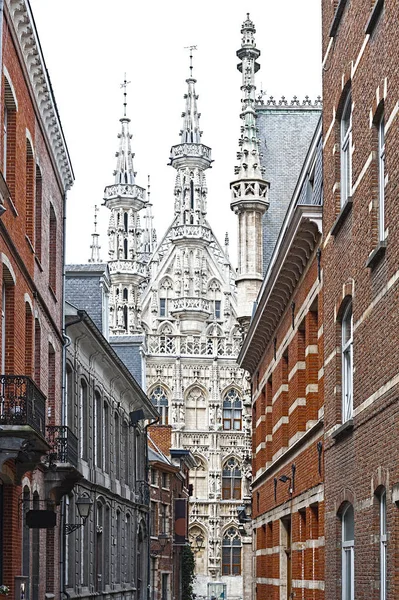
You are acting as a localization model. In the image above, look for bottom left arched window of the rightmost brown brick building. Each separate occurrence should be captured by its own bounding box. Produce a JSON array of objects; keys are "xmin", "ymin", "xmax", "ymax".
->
[{"xmin": 342, "ymin": 504, "xmax": 355, "ymax": 600}]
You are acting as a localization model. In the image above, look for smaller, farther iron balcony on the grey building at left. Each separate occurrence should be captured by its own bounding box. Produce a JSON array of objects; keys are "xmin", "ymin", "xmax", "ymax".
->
[{"xmin": 44, "ymin": 425, "xmax": 82, "ymax": 504}]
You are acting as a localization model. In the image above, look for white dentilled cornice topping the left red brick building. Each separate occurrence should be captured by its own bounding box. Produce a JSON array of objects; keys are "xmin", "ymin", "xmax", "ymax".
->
[{"xmin": 6, "ymin": 0, "xmax": 74, "ymax": 192}]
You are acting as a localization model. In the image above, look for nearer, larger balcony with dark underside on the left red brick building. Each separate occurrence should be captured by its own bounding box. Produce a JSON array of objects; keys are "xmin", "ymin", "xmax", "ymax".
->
[{"xmin": 0, "ymin": 375, "xmax": 49, "ymax": 483}]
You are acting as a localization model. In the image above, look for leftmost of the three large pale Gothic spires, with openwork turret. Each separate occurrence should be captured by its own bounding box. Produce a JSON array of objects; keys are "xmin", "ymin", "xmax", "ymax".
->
[{"xmin": 104, "ymin": 76, "xmax": 147, "ymax": 335}]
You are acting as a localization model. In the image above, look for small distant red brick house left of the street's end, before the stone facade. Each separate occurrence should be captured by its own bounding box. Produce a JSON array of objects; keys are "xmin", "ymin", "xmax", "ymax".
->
[{"xmin": 148, "ymin": 425, "xmax": 196, "ymax": 600}]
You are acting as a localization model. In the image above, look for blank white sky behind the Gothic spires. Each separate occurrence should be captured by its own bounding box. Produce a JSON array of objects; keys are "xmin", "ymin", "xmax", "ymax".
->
[{"xmin": 30, "ymin": 0, "xmax": 321, "ymax": 263}]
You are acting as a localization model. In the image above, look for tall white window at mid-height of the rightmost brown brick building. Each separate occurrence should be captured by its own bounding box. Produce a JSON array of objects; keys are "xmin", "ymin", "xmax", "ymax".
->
[{"xmin": 341, "ymin": 302, "xmax": 353, "ymax": 423}]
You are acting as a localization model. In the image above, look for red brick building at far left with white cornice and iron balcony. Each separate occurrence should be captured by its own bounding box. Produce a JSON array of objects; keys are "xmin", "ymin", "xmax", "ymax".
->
[{"xmin": 0, "ymin": 0, "xmax": 73, "ymax": 600}]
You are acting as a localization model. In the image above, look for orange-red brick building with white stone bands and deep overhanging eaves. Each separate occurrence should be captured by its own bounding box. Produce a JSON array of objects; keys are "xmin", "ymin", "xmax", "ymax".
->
[{"xmin": 239, "ymin": 119, "xmax": 324, "ymax": 600}]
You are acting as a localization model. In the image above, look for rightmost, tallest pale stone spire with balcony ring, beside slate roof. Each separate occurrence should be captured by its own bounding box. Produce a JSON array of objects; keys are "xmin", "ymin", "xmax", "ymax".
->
[{"xmin": 230, "ymin": 13, "xmax": 269, "ymax": 331}]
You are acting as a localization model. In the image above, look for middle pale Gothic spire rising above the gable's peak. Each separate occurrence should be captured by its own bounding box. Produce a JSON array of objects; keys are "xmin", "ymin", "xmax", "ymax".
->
[{"xmin": 169, "ymin": 46, "xmax": 213, "ymax": 231}]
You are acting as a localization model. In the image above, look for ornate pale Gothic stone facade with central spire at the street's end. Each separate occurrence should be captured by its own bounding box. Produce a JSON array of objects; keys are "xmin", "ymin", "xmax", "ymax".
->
[{"xmin": 105, "ymin": 54, "xmax": 251, "ymax": 600}]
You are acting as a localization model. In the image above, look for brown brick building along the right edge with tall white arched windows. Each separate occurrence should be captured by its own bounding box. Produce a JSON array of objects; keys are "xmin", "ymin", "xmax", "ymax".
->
[{"xmin": 322, "ymin": 0, "xmax": 399, "ymax": 600}]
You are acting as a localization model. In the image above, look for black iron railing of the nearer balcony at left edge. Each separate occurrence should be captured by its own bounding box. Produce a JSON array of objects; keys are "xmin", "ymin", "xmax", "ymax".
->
[{"xmin": 0, "ymin": 375, "xmax": 46, "ymax": 437}]
